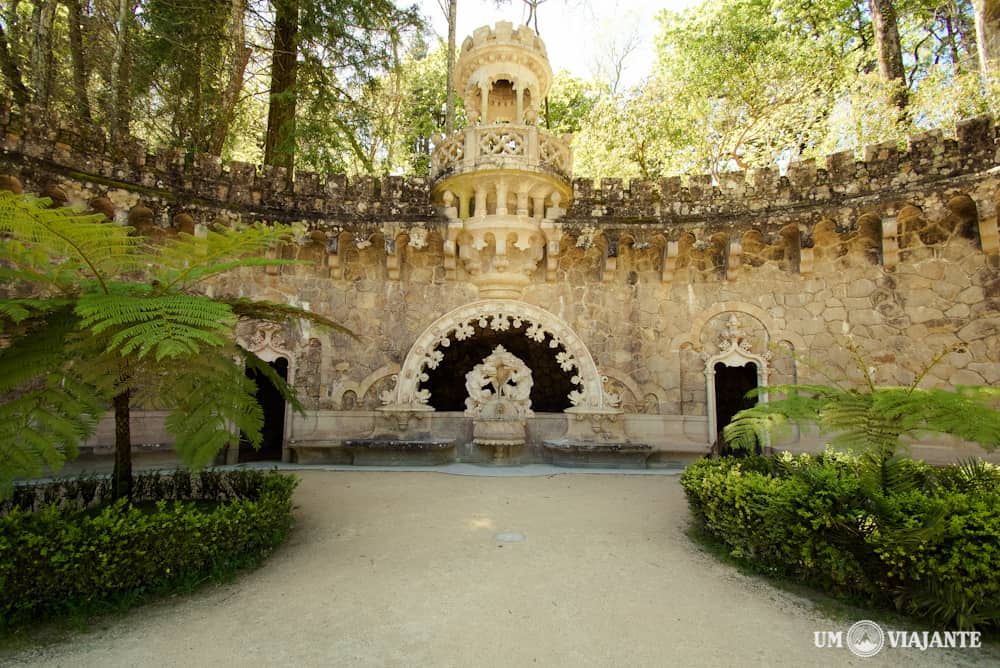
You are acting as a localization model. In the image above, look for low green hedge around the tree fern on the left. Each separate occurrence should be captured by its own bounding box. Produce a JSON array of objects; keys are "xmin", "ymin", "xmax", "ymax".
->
[{"xmin": 0, "ymin": 471, "xmax": 298, "ymax": 627}]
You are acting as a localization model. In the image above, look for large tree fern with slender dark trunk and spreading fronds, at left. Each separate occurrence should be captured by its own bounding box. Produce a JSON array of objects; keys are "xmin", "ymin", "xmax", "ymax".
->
[{"xmin": 0, "ymin": 192, "xmax": 350, "ymax": 497}]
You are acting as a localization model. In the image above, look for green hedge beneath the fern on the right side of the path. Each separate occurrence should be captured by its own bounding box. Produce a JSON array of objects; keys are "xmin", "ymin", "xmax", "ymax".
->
[{"xmin": 681, "ymin": 453, "xmax": 1000, "ymax": 629}]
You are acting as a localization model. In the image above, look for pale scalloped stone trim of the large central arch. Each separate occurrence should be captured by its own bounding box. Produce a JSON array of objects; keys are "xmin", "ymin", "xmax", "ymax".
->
[{"xmin": 380, "ymin": 299, "xmax": 614, "ymax": 411}]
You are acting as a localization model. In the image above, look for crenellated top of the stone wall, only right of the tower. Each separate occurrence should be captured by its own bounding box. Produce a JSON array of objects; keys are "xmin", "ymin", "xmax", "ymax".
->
[{"xmin": 566, "ymin": 115, "xmax": 997, "ymax": 223}]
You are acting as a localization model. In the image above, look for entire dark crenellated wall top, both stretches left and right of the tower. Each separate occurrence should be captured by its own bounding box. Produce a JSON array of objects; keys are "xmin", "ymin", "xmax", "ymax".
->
[{"xmin": 0, "ymin": 96, "xmax": 997, "ymax": 231}]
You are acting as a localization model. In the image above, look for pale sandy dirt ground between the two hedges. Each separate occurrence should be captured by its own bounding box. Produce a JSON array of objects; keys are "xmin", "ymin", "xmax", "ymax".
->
[{"xmin": 3, "ymin": 471, "xmax": 1000, "ymax": 667}]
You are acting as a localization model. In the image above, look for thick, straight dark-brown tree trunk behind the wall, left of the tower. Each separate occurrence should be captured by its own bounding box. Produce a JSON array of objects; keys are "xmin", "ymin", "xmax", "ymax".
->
[{"xmin": 264, "ymin": 0, "xmax": 299, "ymax": 176}]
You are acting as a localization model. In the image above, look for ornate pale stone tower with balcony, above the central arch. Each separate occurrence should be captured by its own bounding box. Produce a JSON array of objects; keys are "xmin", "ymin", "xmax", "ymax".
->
[{"xmin": 431, "ymin": 22, "xmax": 573, "ymax": 299}]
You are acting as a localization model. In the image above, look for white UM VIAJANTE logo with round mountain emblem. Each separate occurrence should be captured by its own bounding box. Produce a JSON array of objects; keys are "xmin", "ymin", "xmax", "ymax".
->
[{"xmin": 813, "ymin": 619, "xmax": 982, "ymax": 658}]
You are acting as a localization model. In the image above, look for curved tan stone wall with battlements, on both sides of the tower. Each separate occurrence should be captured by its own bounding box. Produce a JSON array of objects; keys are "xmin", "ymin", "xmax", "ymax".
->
[{"xmin": 0, "ymin": 99, "xmax": 1000, "ymax": 459}]
